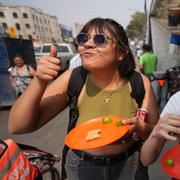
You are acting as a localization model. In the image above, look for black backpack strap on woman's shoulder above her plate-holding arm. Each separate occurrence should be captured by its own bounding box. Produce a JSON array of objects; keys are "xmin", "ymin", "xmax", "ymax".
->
[{"xmin": 129, "ymin": 71, "xmax": 145, "ymax": 108}]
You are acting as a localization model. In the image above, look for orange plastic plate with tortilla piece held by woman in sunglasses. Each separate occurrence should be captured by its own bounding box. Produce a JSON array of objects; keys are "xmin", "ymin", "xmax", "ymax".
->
[{"xmin": 65, "ymin": 116, "xmax": 129, "ymax": 150}]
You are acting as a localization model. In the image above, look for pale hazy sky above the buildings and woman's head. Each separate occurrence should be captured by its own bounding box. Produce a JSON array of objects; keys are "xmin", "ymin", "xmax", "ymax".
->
[{"xmin": 0, "ymin": 0, "xmax": 151, "ymax": 34}]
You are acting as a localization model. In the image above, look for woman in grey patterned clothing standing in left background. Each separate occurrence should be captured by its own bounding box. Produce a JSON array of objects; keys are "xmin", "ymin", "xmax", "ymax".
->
[{"xmin": 9, "ymin": 55, "xmax": 35, "ymax": 98}]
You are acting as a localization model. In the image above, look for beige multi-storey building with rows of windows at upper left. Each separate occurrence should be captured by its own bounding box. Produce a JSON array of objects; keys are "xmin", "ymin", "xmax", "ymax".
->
[{"xmin": 0, "ymin": 4, "xmax": 62, "ymax": 43}]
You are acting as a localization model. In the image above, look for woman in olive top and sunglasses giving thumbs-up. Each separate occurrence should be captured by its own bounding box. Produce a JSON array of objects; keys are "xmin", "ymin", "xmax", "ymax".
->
[{"xmin": 9, "ymin": 18, "xmax": 158, "ymax": 180}]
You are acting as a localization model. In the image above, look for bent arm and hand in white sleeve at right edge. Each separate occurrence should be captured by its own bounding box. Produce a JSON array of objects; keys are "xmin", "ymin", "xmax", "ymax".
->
[{"xmin": 141, "ymin": 91, "xmax": 180, "ymax": 169}]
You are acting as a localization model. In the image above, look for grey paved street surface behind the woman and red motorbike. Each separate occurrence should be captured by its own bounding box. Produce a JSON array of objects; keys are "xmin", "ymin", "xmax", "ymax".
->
[{"xmin": 0, "ymin": 107, "xmax": 172, "ymax": 180}]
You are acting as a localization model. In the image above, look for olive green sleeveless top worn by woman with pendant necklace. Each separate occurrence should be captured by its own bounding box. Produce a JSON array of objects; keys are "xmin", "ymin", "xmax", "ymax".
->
[{"xmin": 76, "ymin": 75, "xmax": 137, "ymax": 125}]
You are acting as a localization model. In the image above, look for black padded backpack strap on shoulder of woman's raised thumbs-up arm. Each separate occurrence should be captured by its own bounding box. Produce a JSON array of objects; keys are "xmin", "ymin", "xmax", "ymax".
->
[{"xmin": 67, "ymin": 66, "xmax": 88, "ymax": 98}]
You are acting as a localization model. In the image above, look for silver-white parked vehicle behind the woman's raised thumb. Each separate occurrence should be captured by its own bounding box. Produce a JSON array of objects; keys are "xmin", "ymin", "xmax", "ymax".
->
[{"xmin": 35, "ymin": 43, "xmax": 76, "ymax": 71}]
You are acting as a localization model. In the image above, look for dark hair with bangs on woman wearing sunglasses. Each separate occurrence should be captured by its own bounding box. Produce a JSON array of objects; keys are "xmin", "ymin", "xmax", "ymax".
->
[{"xmin": 81, "ymin": 18, "xmax": 135, "ymax": 77}]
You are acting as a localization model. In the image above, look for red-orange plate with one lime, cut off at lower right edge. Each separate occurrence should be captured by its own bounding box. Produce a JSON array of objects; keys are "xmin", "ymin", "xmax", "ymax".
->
[{"xmin": 161, "ymin": 144, "xmax": 180, "ymax": 179}]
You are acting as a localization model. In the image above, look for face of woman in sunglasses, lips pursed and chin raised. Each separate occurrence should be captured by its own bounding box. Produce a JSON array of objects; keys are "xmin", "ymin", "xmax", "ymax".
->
[{"xmin": 78, "ymin": 30, "xmax": 120, "ymax": 70}]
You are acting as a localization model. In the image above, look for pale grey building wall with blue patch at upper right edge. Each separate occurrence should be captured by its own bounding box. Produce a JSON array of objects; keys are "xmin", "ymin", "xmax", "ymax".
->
[{"xmin": 146, "ymin": 0, "xmax": 180, "ymax": 71}]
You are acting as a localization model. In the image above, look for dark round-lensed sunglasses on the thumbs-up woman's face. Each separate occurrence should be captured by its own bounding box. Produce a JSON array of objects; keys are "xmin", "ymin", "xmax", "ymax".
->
[{"xmin": 76, "ymin": 33, "xmax": 110, "ymax": 47}]
